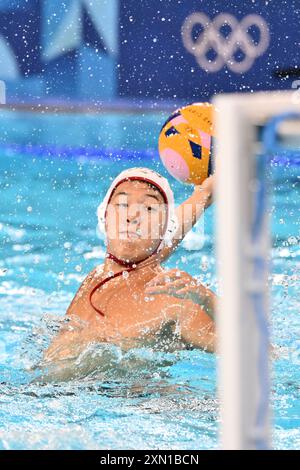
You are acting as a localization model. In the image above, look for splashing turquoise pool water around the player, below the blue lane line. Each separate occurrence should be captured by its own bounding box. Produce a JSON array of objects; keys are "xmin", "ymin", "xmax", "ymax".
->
[{"xmin": 0, "ymin": 120, "xmax": 300, "ymax": 450}]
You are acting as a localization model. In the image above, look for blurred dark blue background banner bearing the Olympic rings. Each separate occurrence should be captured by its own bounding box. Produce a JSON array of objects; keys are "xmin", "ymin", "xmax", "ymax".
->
[{"xmin": 0, "ymin": 0, "xmax": 300, "ymax": 102}]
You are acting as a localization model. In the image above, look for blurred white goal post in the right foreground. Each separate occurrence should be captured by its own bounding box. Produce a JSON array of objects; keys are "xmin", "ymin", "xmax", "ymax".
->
[{"xmin": 213, "ymin": 91, "xmax": 300, "ymax": 449}]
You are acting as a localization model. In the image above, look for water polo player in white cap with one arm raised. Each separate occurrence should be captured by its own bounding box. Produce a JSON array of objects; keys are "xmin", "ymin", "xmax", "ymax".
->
[{"xmin": 45, "ymin": 168, "xmax": 215, "ymax": 361}]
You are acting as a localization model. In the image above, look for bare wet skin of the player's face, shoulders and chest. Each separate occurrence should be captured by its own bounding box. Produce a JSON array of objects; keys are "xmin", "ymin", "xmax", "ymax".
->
[{"xmin": 44, "ymin": 181, "xmax": 215, "ymax": 361}]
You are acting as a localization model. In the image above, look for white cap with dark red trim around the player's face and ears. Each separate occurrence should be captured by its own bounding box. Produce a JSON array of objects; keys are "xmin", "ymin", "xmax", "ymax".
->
[{"xmin": 97, "ymin": 167, "xmax": 178, "ymax": 256}]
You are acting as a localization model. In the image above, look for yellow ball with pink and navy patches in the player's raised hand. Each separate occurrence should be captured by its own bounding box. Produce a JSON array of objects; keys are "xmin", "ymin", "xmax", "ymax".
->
[{"xmin": 158, "ymin": 103, "xmax": 214, "ymax": 185}]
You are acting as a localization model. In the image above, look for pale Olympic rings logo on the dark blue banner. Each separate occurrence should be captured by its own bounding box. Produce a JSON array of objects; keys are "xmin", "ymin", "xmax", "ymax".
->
[{"xmin": 181, "ymin": 12, "xmax": 270, "ymax": 73}]
